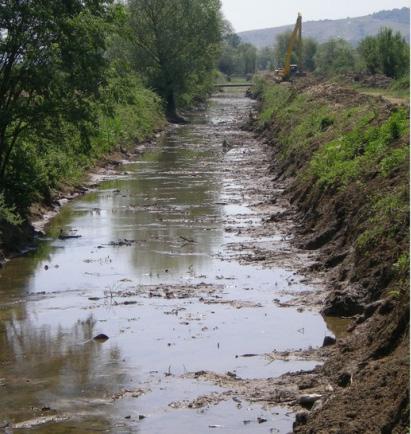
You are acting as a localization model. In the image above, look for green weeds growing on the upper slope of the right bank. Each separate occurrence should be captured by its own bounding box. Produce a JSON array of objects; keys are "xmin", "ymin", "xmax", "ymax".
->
[{"xmin": 256, "ymin": 82, "xmax": 409, "ymax": 296}]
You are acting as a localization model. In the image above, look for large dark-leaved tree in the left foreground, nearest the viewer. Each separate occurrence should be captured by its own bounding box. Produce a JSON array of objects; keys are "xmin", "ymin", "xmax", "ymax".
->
[{"xmin": 0, "ymin": 0, "xmax": 117, "ymax": 197}]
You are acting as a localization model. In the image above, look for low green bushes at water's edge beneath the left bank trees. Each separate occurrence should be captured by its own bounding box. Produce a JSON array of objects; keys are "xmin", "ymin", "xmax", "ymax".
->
[{"xmin": 3, "ymin": 75, "xmax": 163, "ymax": 215}]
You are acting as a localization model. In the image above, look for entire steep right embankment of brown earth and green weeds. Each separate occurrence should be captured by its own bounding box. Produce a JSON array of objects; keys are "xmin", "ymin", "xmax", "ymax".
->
[{"xmin": 252, "ymin": 79, "xmax": 409, "ymax": 434}]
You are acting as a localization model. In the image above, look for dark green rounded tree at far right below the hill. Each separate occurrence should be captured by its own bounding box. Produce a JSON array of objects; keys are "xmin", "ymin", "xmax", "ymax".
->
[{"xmin": 358, "ymin": 28, "xmax": 409, "ymax": 78}]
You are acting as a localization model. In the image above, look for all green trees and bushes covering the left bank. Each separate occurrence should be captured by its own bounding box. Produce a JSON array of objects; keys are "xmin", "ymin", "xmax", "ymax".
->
[{"xmin": 0, "ymin": 0, "xmax": 222, "ymax": 237}]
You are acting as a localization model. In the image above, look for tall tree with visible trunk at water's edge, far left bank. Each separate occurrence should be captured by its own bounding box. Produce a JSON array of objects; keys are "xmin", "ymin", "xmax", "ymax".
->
[{"xmin": 129, "ymin": 0, "xmax": 223, "ymax": 121}]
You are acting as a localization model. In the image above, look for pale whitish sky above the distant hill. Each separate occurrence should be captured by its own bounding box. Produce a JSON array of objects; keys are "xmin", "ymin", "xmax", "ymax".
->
[{"xmin": 222, "ymin": 0, "xmax": 410, "ymax": 32}]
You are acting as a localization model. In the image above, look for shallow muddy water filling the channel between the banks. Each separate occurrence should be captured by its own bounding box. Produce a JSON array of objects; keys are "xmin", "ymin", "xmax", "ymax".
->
[{"xmin": 0, "ymin": 90, "xmax": 328, "ymax": 434}]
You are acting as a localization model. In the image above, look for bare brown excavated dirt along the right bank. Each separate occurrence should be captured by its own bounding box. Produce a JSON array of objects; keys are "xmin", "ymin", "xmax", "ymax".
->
[{"xmin": 249, "ymin": 80, "xmax": 409, "ymax": 434}]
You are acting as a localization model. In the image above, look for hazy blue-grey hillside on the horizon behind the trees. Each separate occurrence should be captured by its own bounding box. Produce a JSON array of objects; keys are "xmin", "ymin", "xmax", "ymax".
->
[{"xmin": 239, "ymin": 8, "xmax": 410, "ymax": 48}]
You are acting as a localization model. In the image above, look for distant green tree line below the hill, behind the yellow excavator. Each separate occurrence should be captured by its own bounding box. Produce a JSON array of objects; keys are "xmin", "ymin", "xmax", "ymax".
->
[{"xmin": 219, "ymin": 28, "xmax": 410, "ymax": 79}]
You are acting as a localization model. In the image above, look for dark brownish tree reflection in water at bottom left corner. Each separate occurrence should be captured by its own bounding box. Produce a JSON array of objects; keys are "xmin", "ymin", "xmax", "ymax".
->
[{"xmin": 0, "ymin": 308, "xmax": 125, "ymax": 428}]
